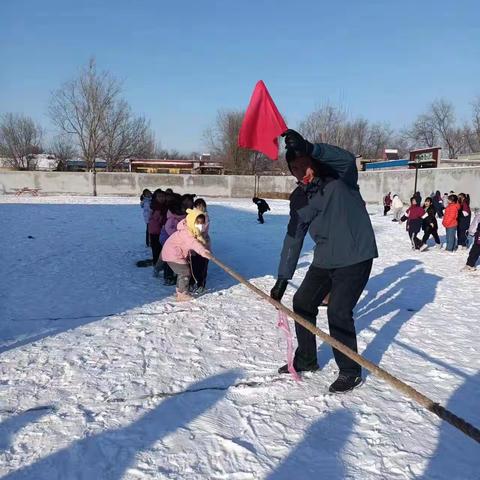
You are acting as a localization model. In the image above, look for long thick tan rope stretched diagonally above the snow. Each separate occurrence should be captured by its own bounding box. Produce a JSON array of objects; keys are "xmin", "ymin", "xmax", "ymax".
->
[{"xmin": 211, "ymin": 256, "xmax": 480, "ymax": 443}]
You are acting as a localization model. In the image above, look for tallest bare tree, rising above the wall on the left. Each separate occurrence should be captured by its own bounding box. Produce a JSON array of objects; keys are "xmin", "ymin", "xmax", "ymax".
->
[{"xmin": 49, "ymin": 59, "xmax": 120, "ymax": 169}]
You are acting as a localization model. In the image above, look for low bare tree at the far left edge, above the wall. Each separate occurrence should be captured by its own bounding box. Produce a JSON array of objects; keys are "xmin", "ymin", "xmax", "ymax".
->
[{"xmin": 0, "ymin": 113, "xmax": 43, "ymax": 170}]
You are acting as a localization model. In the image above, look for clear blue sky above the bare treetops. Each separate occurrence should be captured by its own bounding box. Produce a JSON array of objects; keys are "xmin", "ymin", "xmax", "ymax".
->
[{"xmin": 0, "ymin": 0, "xmax": 480, "ymax": 152}]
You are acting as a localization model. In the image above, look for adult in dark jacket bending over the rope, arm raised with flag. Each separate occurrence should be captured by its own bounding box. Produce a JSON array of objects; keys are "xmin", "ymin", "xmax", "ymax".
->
[{"xmin": 271, "ymin": 130, "xmax": 378, "ymax": 392}]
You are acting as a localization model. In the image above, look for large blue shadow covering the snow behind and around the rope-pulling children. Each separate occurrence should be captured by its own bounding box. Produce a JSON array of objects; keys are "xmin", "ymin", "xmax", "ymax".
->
[{"xmin": 0, "ymin": 204, "xmax": 300, "ymax": 354}]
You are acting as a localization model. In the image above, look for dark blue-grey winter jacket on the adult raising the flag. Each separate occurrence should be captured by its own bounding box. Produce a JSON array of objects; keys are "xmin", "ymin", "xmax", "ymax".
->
[{"xmin": 278, "ymin": 143, "xmax": 378, "ymax": 279}]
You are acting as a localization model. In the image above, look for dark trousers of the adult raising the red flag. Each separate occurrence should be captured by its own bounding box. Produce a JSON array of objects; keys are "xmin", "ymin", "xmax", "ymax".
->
[{"xmin": 293, "ymin": 260, "xmax": 373, "ymax": 376}]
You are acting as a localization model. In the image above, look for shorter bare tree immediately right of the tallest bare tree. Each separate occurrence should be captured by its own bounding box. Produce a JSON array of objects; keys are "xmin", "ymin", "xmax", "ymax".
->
[{"xmin": 100, "ymin": 100, "xmax": 155, "ymax": 172}]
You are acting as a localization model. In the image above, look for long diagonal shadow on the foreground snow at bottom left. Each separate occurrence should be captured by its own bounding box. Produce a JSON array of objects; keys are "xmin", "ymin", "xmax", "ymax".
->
[{"xmin": 2, "ymin": 370, "xmax": 239, "ymax": 480}]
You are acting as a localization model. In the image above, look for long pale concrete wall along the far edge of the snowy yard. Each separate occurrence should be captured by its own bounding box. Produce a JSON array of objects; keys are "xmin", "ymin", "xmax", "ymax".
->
[{"xmin": 0, "ymin": 167, "xmax": 480, "ymax": 207}]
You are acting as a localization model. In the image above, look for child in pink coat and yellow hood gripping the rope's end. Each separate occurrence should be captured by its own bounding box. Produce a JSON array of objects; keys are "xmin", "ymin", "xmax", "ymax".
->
[{"xmin": 162, "ymin": 209, "xmax": 211, "ymax": 302}]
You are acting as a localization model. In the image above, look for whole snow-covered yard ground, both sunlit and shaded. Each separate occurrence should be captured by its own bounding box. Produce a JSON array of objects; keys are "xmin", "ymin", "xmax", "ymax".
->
[{"xmin": 0, "ymin": 197, "xmax": 480, "ymax": 480}]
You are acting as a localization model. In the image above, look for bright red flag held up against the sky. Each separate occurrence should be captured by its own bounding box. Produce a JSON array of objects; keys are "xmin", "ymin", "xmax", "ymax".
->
[{"xmin": 238, "ymin": 80, "xmax": 288, "ymax": 160}]
